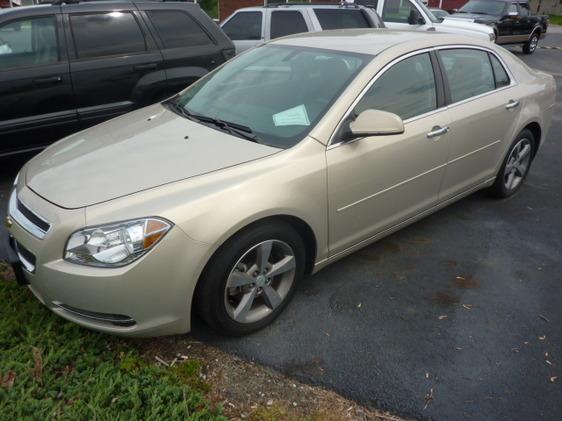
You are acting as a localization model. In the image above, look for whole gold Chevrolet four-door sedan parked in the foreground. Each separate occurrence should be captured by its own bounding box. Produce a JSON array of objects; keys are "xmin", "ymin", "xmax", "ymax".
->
[{"xmin": 7, "ymin": 30, "xmax": 556, "ymax": 336}]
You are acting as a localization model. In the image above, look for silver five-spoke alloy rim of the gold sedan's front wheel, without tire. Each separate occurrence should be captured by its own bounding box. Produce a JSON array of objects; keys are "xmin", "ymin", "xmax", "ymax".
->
[{"xmin": 224, "ymin": 240, "xmax": 296, "ymax": 323}]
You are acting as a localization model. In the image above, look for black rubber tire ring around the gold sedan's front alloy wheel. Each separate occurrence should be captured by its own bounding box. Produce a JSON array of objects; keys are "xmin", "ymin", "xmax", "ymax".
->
[{"xmin": 196, "ymin": 221, "xmax": 306, "ymax": 336}]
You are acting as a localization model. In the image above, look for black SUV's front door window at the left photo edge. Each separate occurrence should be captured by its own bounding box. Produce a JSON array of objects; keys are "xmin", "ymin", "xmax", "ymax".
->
[{"xmin": 0, "ymin": 16, "xmax": 59, "ymax": 70}]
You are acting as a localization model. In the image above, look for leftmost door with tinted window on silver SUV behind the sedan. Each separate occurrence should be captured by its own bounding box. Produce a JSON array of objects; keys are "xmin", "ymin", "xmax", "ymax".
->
[{"xmin": 221, "ymin": 10, "xmax": 265, "ymax": 54}]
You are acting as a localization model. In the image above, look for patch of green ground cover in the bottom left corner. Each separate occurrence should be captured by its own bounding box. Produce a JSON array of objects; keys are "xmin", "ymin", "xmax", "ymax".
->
[{"xmin": 0, "ymin": 263, "xmax": 225, "ymax": 421}]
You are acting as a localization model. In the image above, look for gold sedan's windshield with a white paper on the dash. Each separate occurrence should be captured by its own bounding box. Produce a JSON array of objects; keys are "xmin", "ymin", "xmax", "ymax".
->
[{"xmin": 176, "ymin": 45, "xmax": 372, "ymax": 148}]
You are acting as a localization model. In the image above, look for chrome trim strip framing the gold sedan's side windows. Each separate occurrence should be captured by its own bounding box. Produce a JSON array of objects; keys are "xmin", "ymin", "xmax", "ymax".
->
[{"xmin": 326, "ymin": 44, "xmax": 517, "ymax": 150}]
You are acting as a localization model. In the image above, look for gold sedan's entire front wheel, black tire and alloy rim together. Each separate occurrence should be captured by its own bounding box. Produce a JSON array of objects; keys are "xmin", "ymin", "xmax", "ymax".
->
[{"xmin": 195, "ymin": 221, "xmax": 306, "ymax": 336}]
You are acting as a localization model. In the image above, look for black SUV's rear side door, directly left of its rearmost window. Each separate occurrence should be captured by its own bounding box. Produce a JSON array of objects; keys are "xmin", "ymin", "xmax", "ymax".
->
[{"xmin": 63, "ymin": 2, "xmax": 166, "ymax": 126}]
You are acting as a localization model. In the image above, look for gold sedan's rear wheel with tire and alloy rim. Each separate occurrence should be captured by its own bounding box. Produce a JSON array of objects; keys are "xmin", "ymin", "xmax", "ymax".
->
[{"xmin": 489, "ymin": 129, "xmax": 536, "ymax": 198}]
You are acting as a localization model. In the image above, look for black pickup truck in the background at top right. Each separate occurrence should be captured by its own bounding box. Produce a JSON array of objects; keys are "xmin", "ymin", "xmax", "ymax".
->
[{"xmin": 447, "ymin": 0, "xmax": 548, "ymax": 54}]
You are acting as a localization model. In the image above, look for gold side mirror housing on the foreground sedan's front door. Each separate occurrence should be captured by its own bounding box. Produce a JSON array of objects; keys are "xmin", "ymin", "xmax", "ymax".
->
[{"xmin": 346, "ymin": 110, "xmax": 404, "ymax": 140}]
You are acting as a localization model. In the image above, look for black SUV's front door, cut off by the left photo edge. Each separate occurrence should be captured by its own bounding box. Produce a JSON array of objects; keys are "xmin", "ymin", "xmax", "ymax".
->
[{"xmin": 0, "ymin": 10, "xmax": 77, "ymax": 155}]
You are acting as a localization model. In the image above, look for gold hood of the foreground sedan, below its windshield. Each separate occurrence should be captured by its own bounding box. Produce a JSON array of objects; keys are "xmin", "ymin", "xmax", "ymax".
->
[{"xmin": 25, "ymin": 104, "xmax": 281, "ymax": 208}]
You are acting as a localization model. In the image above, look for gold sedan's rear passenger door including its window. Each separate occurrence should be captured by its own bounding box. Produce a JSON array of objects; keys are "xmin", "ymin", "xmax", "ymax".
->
[{"xmin": 438, "ymin": 48, "xmax": 521, "ymax": 200}]
